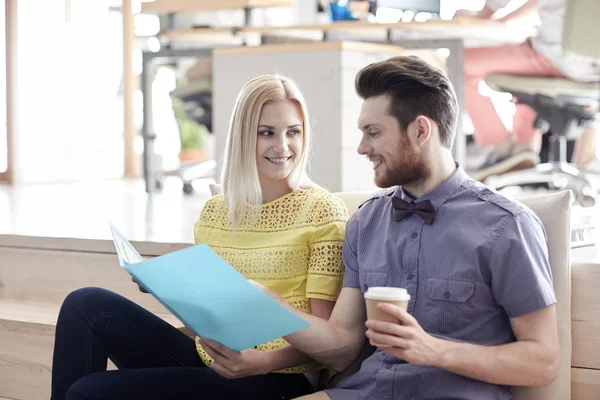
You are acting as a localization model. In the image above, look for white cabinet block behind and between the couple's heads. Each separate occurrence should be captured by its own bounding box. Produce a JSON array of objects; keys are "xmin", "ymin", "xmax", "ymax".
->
[{"xmin": 213, "ymin": 44, "xmax": 401, "ymax": 192}]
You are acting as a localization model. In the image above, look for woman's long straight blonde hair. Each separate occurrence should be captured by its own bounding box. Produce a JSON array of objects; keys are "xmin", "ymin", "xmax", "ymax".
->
[{"xmin": 221, "ymin": 75, "xmax": 314, "ymax": 224}]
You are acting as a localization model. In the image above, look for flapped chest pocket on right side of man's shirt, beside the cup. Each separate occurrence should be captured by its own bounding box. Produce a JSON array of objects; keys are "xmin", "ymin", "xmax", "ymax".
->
[{"xmin": 424, "ymin": 277, "xmax": 475, "ymax": 334}]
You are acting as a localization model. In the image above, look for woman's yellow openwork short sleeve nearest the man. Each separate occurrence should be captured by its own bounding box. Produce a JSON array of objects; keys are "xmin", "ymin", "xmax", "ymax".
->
[{"xmin": 306, "ymin": 196, "xmax": 348, "ymax": 301}]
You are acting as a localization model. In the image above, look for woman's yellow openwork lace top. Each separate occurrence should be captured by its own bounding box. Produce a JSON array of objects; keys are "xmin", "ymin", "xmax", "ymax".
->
[{"xmin": 194, "ymin": 188, "xmax": 348, "ymax": 373}]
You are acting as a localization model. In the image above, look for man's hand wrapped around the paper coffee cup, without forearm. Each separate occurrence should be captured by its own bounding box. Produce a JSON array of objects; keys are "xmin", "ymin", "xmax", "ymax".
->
[{"xmin": 366, "ymin": 304, "xmax": 442, "ymax": 365}]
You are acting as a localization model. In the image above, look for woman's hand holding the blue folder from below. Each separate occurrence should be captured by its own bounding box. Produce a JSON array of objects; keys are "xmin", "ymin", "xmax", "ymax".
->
[{"xmin": 200, "ymin": 338, "xmax": 271, "ymax": 379}]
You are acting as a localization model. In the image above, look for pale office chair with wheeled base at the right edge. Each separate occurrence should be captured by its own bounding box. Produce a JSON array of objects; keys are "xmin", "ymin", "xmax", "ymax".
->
[{"xmin": 485, "ymin": 0, "xmax": 600, "ymax": 206}]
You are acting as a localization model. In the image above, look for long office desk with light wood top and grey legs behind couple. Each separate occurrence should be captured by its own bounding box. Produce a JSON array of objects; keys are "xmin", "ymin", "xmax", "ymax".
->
[{"xmin": 142, "ymin": 19, "xmax": 532, "ymax": 192}]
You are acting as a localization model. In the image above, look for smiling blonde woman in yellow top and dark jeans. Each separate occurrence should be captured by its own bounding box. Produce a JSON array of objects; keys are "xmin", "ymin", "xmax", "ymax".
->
[{"xmin": 52, "ymin": 75, "xmax": 347, "ymax": 400}]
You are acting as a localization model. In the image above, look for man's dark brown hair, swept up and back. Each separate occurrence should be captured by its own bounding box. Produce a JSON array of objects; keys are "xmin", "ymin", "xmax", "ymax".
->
[{"xmin": 355, "ymin": 56, "xmax": 458, "ymax": 149}]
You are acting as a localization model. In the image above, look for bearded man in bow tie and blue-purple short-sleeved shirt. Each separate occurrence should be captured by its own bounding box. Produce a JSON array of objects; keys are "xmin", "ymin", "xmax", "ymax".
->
[{"xmin": 248, "ymin": 57, "xmax": 559, "ymax": 400}]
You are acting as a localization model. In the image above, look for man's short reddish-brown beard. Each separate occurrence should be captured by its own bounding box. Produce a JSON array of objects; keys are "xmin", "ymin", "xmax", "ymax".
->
[{"xmin": 375, "ymin": 148, "xmax": 431, "ymax": 188}]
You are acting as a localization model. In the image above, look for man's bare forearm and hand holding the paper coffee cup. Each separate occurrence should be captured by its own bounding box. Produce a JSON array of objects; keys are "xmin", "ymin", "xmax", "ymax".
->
[{"xmin": 366, "ymin": 304, "xmax": 560, "ymax": 386}]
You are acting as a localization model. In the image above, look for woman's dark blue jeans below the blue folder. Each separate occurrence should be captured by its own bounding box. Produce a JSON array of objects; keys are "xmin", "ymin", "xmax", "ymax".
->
[{"xmin": 52, "ymin": 288, "xmax": 313, "ymax": 400}]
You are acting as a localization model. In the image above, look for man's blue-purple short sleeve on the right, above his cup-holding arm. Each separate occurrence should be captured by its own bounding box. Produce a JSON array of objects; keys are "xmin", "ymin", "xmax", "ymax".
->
[{"xmin": 489, "ymin": 212, "xmax": 556, "ymax": 318}]
